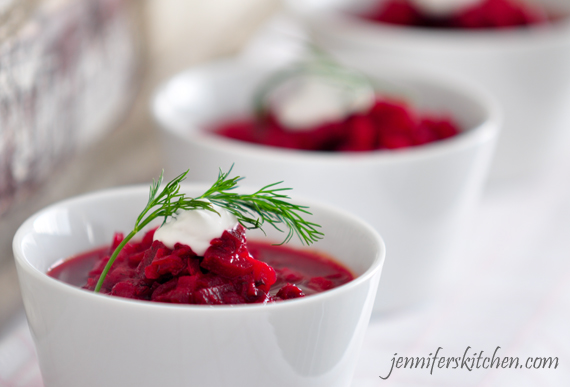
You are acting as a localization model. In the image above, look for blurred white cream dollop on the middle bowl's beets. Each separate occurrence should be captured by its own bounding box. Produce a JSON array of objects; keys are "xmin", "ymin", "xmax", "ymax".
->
[{"xmin": 271, "ymin": 74, "xmax": 374, "ymax": 131}]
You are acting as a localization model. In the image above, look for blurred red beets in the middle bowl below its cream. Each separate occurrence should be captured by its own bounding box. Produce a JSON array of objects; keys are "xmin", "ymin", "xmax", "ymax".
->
[{"xmin": 214, "ymin": 100, "xmax": 459, "ymax": 152}]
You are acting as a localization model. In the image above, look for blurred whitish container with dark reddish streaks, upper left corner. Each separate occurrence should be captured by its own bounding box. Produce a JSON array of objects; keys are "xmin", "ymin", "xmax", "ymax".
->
[{"xmin": 0, "ymin": 0, "xmax": 144, "ymax": 217}]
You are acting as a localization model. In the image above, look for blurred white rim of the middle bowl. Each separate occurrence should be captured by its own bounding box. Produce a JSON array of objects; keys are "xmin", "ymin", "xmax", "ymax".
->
[{"xmin": 150, "ymin": 57, "xmax": 503, "ymax": 164}]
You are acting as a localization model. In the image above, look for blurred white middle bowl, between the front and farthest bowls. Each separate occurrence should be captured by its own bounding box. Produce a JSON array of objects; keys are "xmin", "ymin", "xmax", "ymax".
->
[{"xmin": 153, "ymin": 60, "xmax": 500, "ymax": 310}]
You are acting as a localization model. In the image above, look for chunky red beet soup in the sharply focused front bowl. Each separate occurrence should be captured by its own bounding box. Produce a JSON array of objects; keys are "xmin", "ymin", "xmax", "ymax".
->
[{"xmin": 47, "ymin": 226, "xmax": 354, "ymax": 305}]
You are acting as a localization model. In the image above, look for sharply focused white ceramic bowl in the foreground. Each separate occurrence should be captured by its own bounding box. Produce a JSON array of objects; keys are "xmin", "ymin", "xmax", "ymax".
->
[{"xmin": 13, "ymin": 186, "xmax": 385, "ymax": 387}]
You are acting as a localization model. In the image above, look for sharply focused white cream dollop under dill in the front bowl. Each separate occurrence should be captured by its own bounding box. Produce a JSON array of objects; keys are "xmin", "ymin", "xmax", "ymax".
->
[{"xmin": 154, "ymin": 204, "xmax": 238, "ymax": 256}]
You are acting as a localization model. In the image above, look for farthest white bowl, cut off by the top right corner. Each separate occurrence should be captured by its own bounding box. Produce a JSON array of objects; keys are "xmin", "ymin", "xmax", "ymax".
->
[{"xmin": 287, "ymin": 0, "xmax": 570, "ymax": 180}]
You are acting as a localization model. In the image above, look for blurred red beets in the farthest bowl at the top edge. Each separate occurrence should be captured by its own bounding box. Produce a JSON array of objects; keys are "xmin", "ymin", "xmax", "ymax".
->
[{"xmin": 364, "ymin": 0, "xmax": 554, "ymax": 29}]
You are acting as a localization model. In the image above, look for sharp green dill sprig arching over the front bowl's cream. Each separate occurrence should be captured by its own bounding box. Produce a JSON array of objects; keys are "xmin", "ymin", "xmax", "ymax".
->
[{"xmin": 94, "ymin": 166, "xmax": 324, "ymax": 292}]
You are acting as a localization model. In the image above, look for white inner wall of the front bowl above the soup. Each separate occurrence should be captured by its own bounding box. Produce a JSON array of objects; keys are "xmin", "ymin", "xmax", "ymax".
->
[{"xmin": 14, "ymin": 186, "xmax": 384, "ymax": 286}]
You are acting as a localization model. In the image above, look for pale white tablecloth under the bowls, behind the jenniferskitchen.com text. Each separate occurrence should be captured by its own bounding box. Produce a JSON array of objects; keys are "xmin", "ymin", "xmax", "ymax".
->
[{"xmin": 0, "ymin": 150, "xmax": 570, "ymax": 387}]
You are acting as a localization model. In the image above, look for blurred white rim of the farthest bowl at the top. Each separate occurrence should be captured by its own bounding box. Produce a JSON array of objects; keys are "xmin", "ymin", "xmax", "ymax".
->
[{"xmin": 285, "ymin": 0, "xmax": 570, "ymax": 45}]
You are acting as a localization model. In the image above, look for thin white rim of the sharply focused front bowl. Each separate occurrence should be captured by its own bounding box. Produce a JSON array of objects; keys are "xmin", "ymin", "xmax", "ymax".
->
[{"xmin": 12, "ymin": 183, "xmax": 386, "ymax": 314}]
